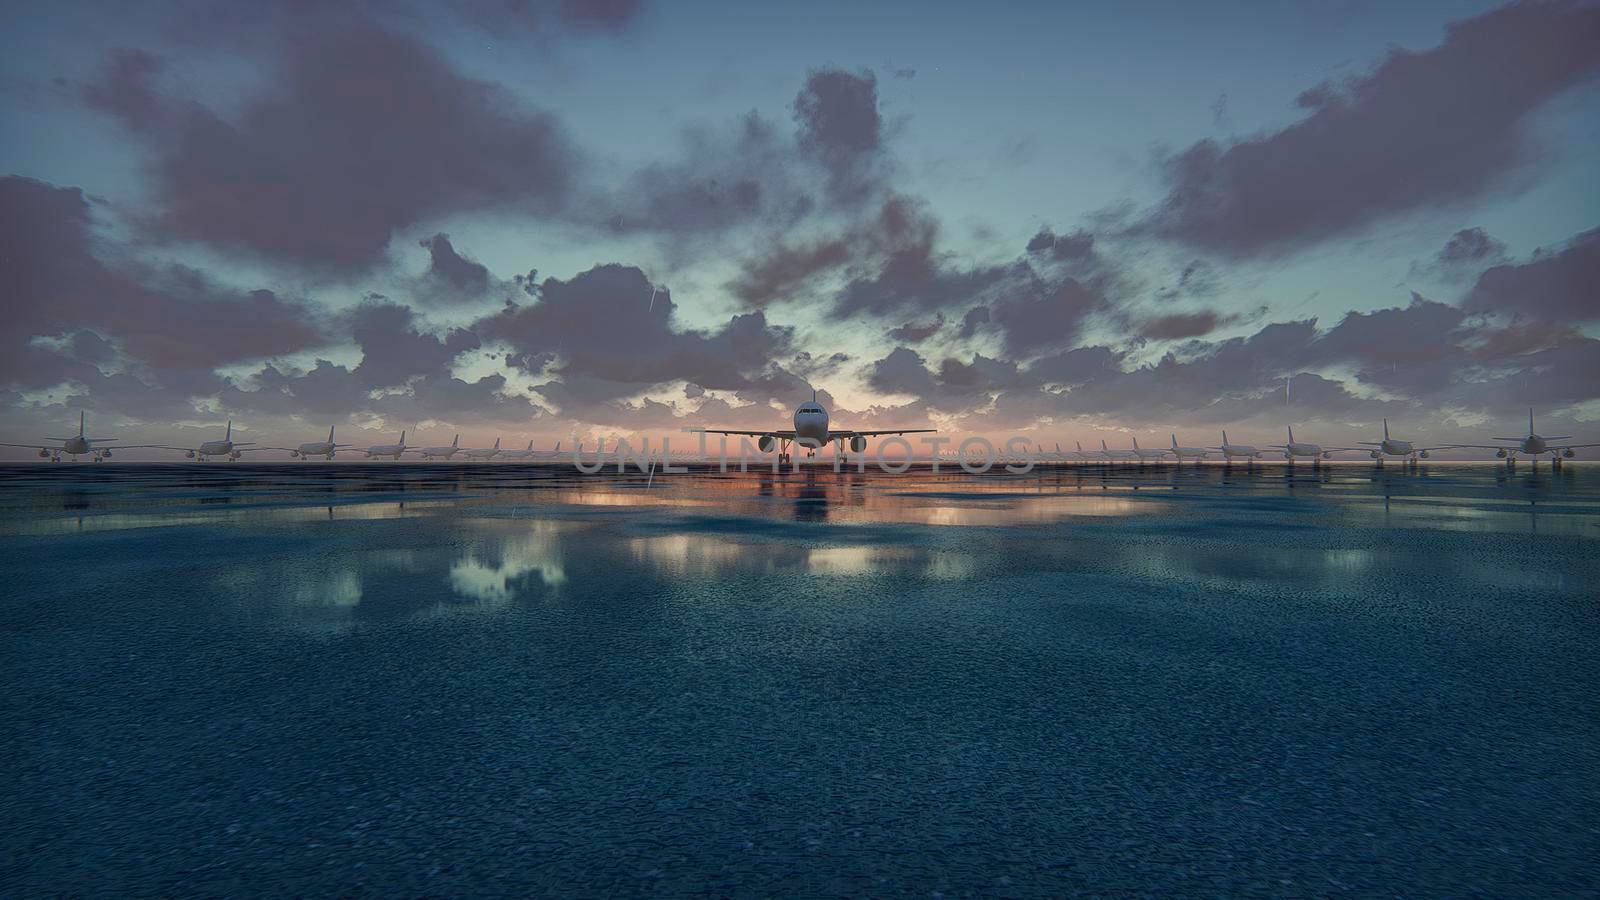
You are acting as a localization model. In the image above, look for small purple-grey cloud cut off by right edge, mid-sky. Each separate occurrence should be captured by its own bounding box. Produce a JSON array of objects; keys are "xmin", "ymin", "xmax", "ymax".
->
[{"xmin": 1466, "ymin": 229, "xmax": 1600, "ymax": 322}]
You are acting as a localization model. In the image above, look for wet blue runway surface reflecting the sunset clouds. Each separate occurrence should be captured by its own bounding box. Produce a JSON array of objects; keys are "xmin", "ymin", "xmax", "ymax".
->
[{"xmin": 0, "ymin": 463, "xmax": 1600, "ymax": 895}]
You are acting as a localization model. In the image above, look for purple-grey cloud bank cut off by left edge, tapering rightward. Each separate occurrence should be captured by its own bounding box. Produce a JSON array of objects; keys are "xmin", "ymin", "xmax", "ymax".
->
[{"xmin": 0, "ymin": 176, "xmax": 322, "ymax": 384}]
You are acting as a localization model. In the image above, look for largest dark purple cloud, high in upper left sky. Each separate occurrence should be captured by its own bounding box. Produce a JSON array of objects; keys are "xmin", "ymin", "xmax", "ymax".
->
[{"xmin": 83, "ymin": 19, "xmax": 578, "ymax": 272}]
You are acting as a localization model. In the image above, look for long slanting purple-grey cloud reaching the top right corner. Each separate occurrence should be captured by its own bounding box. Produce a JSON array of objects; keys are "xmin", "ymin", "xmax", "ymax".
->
[{"xmin": 1136, "ymin": 2, "xmax": 1600, "ymax": 256}]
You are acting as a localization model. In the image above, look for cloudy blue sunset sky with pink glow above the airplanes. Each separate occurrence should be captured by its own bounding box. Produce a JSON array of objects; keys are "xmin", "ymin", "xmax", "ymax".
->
[{"xmin": 0, "ymin": 0, "xmax": 1600, "ymax": 453}]
